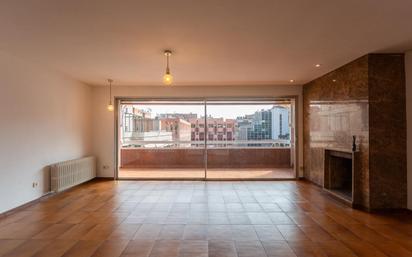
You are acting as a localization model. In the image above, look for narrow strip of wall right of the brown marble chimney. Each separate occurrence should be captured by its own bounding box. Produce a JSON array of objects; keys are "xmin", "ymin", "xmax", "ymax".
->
[{"xmin": 405, "ymin": 51, "xmax": 412, "ymax": 210}]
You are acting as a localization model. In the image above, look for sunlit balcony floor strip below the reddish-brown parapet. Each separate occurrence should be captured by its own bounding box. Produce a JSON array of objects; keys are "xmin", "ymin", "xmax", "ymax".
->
[{"xmin": 119, "ymin": 168, "xmax": 295, "ymax": 180}]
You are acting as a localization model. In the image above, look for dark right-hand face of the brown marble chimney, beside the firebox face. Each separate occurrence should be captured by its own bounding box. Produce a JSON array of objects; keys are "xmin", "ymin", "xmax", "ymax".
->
[{"xmin": 369, "ymin": 54, "xmax": 407, "ymax": 209}]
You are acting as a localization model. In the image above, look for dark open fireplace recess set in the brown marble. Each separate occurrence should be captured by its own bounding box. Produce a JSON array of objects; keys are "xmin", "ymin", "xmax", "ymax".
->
[{"xmin": 323, "ymin": 149, "xmax": 354, "ymax": 205}]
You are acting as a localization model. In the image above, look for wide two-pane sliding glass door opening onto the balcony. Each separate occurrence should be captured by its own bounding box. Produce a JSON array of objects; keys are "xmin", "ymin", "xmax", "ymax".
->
[{"xmin": 118, "ymin": 99, "xmax": 295, "ymax": 180}]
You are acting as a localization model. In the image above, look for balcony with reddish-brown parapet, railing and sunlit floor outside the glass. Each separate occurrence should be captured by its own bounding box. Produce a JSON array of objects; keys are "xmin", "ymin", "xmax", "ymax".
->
[{"xmin": 119, "ymin": 141, "xmax": 295, "ymax": 179}]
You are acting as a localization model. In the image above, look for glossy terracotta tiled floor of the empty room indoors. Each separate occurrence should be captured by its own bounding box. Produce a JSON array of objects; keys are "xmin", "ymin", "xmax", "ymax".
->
[{"xmin": 0, "ymin": 181, "xmax": 412, "ymax": 257}]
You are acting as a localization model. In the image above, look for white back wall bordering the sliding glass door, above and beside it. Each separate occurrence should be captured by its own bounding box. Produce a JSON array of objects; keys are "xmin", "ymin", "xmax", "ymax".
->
[{"xmin": 92, "ymin": 85, "xmax": 303, "ymax": 177}]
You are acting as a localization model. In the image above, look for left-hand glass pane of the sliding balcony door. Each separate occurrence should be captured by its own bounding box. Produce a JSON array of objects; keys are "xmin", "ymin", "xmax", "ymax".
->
[{"xmin": 118, "ymin": 101, "xmax": 205, "ymax": 179}]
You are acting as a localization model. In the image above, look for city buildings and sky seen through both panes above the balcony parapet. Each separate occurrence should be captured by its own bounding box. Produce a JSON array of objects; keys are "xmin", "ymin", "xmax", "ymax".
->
[{"xmin": 120, "ymin": 101, "xmax": 290, "ymax": 148}]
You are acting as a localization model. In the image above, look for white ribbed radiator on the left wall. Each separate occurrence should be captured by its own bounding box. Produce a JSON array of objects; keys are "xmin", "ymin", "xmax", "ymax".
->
[{"xmin": 50, "ymin": 157, "xmax": 96, "ymax": 192}]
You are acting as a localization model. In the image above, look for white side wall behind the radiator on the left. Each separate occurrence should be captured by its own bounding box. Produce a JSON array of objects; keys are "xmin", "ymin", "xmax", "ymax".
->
[{"xmin": 0, "ymin": 52, "xmax": 91, "ymax": 213}]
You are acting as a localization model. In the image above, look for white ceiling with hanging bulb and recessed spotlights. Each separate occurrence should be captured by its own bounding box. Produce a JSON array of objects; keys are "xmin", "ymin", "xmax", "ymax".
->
[{"xmin": 0, "ymin": 0, "xmax": 412, "ymax": 85}]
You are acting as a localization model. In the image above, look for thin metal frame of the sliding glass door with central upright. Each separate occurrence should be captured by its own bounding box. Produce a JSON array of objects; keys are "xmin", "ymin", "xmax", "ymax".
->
[{"xmin": 114, "ymin": 95, "xmax": 301, "ymax": 181}]
